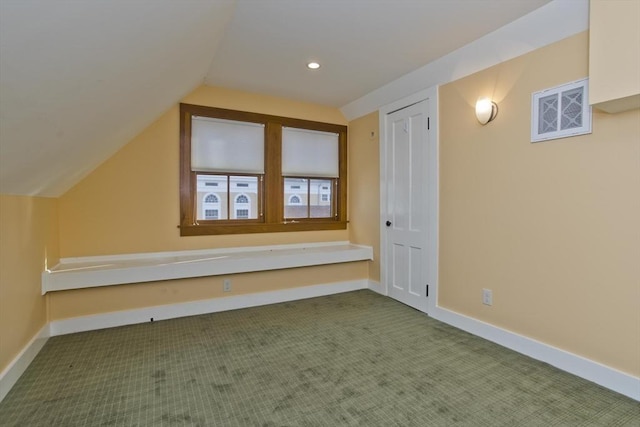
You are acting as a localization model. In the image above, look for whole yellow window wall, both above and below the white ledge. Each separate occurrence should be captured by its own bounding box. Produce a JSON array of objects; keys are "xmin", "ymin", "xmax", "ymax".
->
[{"xmin": 50, "ymin": 86, "xmax": 369, "ymax": 320}]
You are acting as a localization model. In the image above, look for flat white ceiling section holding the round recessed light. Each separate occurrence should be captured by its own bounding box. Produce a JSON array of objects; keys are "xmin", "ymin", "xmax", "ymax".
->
[{"xmin": 205, "ymin": 0, "xmax": 549, "ymax": 107}]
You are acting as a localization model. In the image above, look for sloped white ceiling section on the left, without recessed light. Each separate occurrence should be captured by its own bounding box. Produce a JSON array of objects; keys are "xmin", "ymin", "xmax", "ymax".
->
[{"xmin": 0, "ymin": 0, "xmax": 235, "ymax": 196}]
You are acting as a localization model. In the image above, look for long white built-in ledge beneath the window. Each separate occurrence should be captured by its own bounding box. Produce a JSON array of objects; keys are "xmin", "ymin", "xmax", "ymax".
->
[{"xmin": 42, "ymin": 242, "xmax": 373, "ymax": 295}]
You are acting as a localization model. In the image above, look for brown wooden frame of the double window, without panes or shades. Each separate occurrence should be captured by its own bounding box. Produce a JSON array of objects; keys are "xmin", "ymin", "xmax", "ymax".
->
[{"xmin": 179, "ymin": 104, "xmax": 347, "ymax": 236}]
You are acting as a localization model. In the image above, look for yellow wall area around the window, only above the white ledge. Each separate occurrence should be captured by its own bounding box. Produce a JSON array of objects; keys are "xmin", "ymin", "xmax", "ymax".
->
[{"xmin": 60, "ymin": 86, "xmax": 349, "ymax": 257}]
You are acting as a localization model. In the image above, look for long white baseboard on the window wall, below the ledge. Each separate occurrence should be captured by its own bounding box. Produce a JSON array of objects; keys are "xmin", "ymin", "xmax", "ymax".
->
[{"xmin": 49, "ymin": 279, "xmax": 368, "ymax": 336}]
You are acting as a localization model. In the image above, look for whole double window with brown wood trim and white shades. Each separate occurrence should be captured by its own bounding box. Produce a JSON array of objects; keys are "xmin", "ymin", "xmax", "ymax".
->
[{"xmin": 180, "ymin": 104, "xmax": 347, "ymax": 236}]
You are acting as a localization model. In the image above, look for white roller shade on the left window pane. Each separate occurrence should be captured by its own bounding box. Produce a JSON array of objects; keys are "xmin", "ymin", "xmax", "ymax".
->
[{"xmin": 191, "ymin": 116, "xmax": 264, "ymax": 174}]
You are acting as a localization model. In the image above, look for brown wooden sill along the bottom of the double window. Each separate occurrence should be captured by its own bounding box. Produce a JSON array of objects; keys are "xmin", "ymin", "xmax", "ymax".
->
[{"xmin": 180, "ymin": 220, "xmax": 347, "ymax": 236}]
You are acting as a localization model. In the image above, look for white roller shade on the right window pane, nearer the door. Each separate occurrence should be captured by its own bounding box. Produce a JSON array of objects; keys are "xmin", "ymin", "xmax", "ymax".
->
[{"xmin": 282, "ymin": 127, "xmax": 339, "ymax": 178}]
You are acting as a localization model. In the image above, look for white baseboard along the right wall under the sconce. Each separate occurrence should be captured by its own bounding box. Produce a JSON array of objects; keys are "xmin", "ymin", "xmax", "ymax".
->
[{"xmin": 430, "ymin": 307, "xmax": 640, "ymax": 401}]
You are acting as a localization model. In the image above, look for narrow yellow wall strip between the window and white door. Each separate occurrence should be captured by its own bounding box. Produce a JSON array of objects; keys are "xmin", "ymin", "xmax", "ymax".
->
[{"xmin": 349, "ymin": 111, "xmax": 380, "ymax": 282}]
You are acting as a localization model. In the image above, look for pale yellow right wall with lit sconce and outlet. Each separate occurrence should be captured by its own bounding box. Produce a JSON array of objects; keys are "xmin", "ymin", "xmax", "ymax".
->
[{"xmin": 439, "ymin": 33, "xmax": 640, "ymax": 376}]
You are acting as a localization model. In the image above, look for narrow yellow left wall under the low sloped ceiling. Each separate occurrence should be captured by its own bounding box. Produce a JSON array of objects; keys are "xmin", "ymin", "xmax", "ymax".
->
[{"xmin": 0, "ymin": 195, "xmax": 58, "ymax": 372}]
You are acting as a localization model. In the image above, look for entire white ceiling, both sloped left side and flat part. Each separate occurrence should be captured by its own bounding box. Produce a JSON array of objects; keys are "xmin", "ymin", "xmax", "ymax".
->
[{"xmin": 0, "ymin": 0, "xmax": 557, "ymax": 196}]
